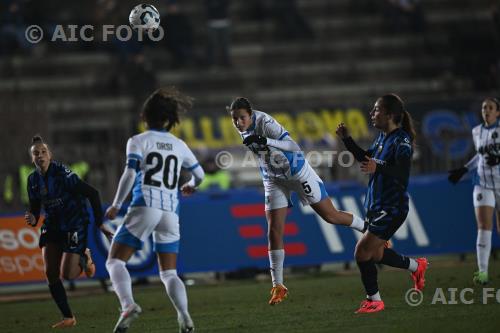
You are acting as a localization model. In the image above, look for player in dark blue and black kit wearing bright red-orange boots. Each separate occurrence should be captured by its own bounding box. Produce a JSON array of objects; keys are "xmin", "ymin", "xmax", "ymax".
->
[{"xmin": 337, "ymin": 94, "xmax": 427, "ymax": 313}]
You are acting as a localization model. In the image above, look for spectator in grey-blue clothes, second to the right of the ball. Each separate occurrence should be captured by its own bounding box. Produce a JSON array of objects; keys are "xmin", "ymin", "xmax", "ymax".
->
[{"xmin": 205, "ymin": 0, "xmax": 231, "ymax": 67}]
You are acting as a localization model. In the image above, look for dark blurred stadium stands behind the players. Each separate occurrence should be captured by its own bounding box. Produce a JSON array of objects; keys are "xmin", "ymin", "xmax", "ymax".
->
[{"xmin": 0, "ymin": 0, "xmax": 500, "ymax": 211}]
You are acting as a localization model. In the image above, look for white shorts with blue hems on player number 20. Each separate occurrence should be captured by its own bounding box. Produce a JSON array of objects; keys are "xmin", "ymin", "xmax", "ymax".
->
[{"xmin": 113, "ymin": 207, "xmax": 180, "ymax": 253}]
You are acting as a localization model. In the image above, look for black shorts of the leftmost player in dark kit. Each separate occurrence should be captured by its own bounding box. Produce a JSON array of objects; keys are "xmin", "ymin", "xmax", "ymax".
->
[{"xmin": 38, "ymin": 224, "xmax": 88, "ymax": 255}]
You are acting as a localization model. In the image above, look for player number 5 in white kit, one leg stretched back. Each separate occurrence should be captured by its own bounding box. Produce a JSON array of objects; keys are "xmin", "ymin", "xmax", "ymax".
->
[{"xmin": 229, "ymin": 97, "xmax": 365, "ymax": 305}]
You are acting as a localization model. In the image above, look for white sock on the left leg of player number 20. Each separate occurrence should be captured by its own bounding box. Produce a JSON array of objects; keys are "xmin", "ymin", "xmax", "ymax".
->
[{"xmin": 106, "ymin": 259, "xmax": 134, "ymax": 311}]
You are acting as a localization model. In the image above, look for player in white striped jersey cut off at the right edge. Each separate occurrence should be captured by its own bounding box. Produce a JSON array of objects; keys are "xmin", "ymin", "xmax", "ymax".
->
[{"xmin": 448, "ymin": 98, "xmax": 500, "ymax": 285}]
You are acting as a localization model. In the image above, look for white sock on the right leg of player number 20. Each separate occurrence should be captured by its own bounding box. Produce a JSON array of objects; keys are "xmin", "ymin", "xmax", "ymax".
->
[{"xmin": 160, "ymin": 269, "xmax": 191, "ymax": 323}]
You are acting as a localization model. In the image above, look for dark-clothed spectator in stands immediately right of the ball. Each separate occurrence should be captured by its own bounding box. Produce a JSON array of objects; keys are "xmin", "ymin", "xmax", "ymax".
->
[{"xmin": 161, "ymin": 0, "xmax": 196, "ymax": 68}]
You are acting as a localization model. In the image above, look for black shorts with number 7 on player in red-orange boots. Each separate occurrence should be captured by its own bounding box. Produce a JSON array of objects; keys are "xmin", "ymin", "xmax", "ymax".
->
[{"xmin": 365, "ymin": 210, "xmax": 408, "ymax": 240}]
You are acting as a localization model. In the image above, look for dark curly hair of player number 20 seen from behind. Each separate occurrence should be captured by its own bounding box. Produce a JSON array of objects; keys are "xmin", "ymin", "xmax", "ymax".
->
[{"xmin": 142, "ymin": 87, "xmax": 193, "ymax": 131}]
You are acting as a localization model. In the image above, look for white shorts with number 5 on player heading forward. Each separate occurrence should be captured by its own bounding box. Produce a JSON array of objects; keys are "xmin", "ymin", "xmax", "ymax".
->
[{"xmin": 264, "ymin": 163, "xmax": 328, "ymax": 210}]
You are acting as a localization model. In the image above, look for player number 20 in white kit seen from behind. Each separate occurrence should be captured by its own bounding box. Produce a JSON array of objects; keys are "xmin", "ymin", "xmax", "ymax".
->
[{"xmin": 106, "ymin": 88, "xmax": 204, "ymax": 332}]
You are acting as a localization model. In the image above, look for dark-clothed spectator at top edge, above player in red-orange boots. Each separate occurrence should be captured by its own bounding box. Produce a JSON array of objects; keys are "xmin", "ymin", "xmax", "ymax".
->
[{"xmin": 383, "ymin": 0, "xmax": 426, "ymax": 33}]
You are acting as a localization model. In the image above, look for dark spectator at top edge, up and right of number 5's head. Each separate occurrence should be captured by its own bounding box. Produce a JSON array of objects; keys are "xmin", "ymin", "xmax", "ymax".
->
[{"xmin": 272, "ymin": 0, "xmax": 315, "ymax": 40}]
